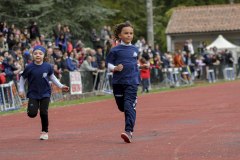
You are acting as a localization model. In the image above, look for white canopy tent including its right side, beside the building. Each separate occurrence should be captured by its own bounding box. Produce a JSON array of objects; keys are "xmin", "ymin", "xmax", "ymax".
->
[{"xmin": 207, "ymin": 35, "xmax": 240, "ymax": 64}]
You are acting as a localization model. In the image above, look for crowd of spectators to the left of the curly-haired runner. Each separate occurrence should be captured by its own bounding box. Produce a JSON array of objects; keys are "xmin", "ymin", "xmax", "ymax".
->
[{"xmin": 0, "ymin": 21, "xmax": 114, "ymax": 87}]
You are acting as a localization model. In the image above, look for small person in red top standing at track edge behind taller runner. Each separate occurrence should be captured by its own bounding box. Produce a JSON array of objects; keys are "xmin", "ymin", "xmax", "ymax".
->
[{"xmin": 139, "ymin": 57, "xmax": 150, "ymax": 93}]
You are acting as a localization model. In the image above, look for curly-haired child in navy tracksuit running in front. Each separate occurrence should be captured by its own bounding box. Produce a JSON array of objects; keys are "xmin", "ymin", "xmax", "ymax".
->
[{"xmin": 107, "ymin": 22, "xmax": 139, "ymax": 143}]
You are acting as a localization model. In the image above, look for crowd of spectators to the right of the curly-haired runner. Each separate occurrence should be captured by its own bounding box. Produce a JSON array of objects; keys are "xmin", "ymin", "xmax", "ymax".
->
[{"xmin": 135, "ymin": 38, "xmax": 236, "ymax": 83}]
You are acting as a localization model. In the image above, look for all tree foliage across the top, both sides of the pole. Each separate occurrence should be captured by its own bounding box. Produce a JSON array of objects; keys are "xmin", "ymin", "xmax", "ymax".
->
[{"xmin": 0, "ymin": 0, "xmax": 240, "ymax": 48}]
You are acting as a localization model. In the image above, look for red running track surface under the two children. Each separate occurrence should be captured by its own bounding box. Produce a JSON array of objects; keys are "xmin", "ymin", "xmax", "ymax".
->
[{"xmin": 0, "ymin": 81, "xmax": 240, "ymax": 160}]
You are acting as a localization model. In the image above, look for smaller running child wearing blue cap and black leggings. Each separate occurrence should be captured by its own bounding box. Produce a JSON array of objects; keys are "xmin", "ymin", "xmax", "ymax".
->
[{"xmin": 19, "ymin": 46, "xmax": 69, "ymax": 140}]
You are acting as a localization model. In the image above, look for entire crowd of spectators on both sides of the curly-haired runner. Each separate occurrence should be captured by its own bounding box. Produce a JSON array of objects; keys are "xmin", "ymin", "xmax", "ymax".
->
[{"xmin": 0, "ymin": 21, "xmax": 240, "ymax": 91}]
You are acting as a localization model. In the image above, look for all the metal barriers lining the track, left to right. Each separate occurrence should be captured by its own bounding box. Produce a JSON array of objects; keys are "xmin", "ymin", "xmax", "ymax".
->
[{"xmin": 0, "ymin": 65, "xmax": 237, "ymax": 111}]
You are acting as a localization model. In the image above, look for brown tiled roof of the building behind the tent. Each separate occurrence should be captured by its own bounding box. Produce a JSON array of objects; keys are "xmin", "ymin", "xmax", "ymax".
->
[{"xmin": 166, "ymin": 4, "xmax": 240, "ymax": 34}]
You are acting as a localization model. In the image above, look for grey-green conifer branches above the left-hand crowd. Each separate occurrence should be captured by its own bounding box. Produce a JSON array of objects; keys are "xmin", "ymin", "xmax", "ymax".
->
[{"xmin": 0, "ymin": 0, "xmax": 116, "ymax": 45}]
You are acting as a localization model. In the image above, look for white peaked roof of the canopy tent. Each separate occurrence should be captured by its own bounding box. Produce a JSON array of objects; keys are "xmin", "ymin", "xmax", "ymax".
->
[{"xmin": 207, "ymin": 35, "xmax": 239, "ymax": 49}]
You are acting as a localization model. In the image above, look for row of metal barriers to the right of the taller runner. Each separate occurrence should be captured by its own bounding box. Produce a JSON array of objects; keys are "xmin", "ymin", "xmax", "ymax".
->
[{"xmin": 150, "ymin": 64, "xmax": 236, "ymax": 87}]
